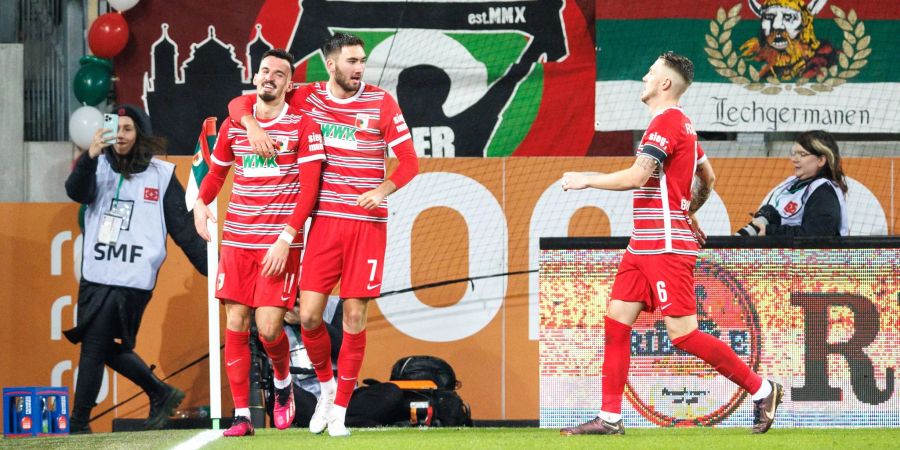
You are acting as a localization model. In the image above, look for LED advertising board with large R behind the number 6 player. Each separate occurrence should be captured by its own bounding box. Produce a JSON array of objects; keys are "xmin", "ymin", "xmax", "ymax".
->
[{"xmin": 540, "ymin": 237, "xmax": 900, "ymax": 428}]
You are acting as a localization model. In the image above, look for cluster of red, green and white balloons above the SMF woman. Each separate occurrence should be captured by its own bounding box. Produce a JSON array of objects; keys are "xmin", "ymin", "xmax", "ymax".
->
[{"xmin": 69, "ymin": 0, "xmax": 139, "ymax": 149}]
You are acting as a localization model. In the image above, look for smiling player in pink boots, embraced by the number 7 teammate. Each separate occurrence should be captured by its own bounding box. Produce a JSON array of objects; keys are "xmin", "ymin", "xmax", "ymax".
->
[{"xmin": 194, "ymin": 49, "xmax": 325, "ymax": 436}]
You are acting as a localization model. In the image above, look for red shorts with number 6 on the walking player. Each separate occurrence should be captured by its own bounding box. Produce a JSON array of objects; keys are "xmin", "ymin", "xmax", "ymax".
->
[{"xmin": 610, "ymin": 251, "xmax": 697, "ymax": 317}]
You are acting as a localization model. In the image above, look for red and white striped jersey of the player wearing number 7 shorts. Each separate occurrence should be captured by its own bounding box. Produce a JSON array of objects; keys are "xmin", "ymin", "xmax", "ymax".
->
[{"xmin": 288, "ymin": 81, "xmax": 412, "ymax": 222}]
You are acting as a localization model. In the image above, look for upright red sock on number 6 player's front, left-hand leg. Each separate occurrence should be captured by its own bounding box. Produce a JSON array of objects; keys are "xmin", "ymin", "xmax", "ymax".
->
[{"xmin": 600, "ymin": 316, "xmax": 631, "ymax": 414}]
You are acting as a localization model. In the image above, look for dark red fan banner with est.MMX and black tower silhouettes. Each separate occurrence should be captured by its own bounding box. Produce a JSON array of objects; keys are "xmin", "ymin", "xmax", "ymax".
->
[{"xmin": 116, "ymin": 0, "xmax": 594, "ymax": 157}]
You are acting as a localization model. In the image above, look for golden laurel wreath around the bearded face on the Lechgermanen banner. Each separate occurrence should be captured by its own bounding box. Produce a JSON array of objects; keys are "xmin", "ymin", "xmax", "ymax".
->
[{"xmin": 704, "ymin": 3, "xmax": 872, "ymax": 95}]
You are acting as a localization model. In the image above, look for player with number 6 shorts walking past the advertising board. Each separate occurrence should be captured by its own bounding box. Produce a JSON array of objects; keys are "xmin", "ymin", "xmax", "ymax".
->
[{"xmin": 561, "ymin": 52, "xmax": 783, "ymax": 435}]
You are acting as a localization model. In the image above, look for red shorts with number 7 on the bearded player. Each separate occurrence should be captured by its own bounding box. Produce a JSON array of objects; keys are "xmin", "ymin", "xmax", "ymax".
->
[{"xmin": 300, "ymin": 216, "xmax": 387, "ymax": 298}]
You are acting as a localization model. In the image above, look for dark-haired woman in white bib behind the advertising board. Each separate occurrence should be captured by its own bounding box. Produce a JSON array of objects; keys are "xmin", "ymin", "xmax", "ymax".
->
[{"xmin": 738, "ymin": 130, "xmax": 849, "ymax": 236}]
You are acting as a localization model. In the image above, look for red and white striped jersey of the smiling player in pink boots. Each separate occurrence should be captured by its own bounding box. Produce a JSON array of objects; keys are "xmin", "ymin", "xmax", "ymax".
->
[{"xmin": 200, "ymin": 104, "xmax": 325, "ymax": 249}]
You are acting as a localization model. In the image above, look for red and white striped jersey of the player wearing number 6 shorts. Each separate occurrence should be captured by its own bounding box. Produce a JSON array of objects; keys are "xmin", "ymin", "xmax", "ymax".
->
[{"xmin": 628, "ymin": 107, "xmax": 706, "ymax": 255}]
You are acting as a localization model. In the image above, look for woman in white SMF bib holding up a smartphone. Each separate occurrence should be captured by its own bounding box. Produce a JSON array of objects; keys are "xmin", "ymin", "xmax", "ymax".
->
[{"xmin": 65, "ymin": 105, "xmax": 207, "ymax": 433}]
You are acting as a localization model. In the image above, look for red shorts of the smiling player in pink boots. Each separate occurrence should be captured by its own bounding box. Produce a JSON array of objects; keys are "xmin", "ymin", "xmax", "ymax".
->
[{"xmin": 216, "ymin": 245, "xmax": 300, "ymax": 309}]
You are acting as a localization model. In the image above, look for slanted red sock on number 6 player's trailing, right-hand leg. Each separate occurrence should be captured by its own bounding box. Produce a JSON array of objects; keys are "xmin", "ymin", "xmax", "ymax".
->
[{"xmin": 672, "ymin": 330, "xmax": 762, "ymax": 394}]
